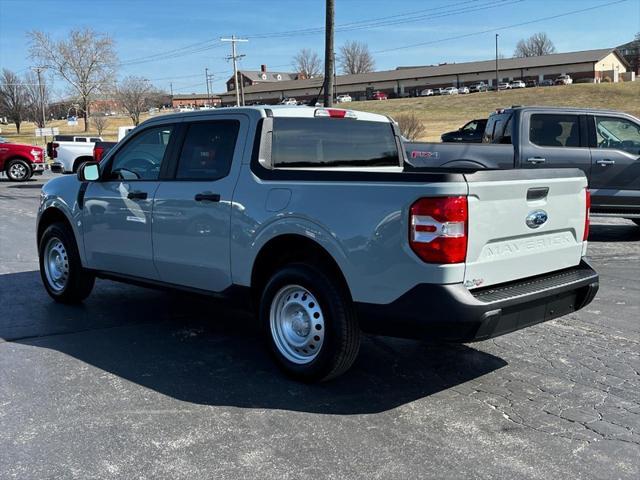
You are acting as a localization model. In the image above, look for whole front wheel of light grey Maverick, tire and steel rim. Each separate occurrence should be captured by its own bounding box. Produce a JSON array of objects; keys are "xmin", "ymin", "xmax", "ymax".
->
[{"xmin": 39, "ymin": 223, "xmax": 95, "ymax": 303}]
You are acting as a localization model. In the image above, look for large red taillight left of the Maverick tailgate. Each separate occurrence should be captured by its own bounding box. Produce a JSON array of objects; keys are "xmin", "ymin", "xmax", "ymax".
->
[{"xmin": 409, "ymin": 197, "xmax": 469, "ymax": 263}]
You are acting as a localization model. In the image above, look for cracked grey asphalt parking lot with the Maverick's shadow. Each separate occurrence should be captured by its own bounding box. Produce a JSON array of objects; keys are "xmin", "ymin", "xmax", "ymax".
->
[{"xmin": 0, "ymin": 177, "xmax": 640, "ymax": 479}]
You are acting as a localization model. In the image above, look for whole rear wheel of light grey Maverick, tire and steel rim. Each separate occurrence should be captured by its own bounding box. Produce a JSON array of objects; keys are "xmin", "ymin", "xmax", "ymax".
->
[{"xmin": 260, "ymin": 263, "xmax": 360, "ymax": 382}]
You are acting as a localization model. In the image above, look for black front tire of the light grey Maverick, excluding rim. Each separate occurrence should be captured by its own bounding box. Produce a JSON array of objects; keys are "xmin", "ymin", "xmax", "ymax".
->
[{"xmin": 38, "ymin": 223, "xmax": 95, "ymax": 303}]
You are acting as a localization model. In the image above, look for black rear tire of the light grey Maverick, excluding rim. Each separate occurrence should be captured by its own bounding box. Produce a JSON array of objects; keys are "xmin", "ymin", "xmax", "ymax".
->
[{"xmin": 259, "ymin": 263, "xmax": 360, "ymax": 382}]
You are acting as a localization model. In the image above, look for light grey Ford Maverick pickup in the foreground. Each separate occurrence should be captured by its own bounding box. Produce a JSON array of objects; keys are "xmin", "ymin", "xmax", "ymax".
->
[{"xmin": 37, "ymin": 107, "xmax": 598, "ymax": 381}]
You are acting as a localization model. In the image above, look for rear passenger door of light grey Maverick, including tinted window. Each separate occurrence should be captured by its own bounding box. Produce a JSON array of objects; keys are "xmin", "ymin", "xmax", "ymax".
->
[{"xmin": 153, "ymin": 115, "xmax": 248, "ymax": 292}]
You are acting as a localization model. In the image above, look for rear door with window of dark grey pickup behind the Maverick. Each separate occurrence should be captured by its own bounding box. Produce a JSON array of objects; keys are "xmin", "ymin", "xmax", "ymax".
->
[{"xmin": 520, "ymin": 112, "xmax": 591, "ymax": 178}]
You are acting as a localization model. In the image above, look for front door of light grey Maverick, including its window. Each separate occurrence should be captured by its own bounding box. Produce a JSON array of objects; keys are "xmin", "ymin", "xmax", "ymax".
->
[{"xmin": 82, "ymin": 125, "xmax": 174, "ymax": 280}]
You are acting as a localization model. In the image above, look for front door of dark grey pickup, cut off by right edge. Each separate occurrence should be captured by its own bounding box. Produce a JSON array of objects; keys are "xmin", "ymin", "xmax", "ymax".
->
[{"xmin": 590, "ymin": 115, "xmax": 640, "ymax": 210}]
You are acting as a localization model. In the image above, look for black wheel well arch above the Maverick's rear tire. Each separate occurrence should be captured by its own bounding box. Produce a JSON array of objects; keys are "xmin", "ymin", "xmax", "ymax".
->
[{"xmin": 251, "ymin": 234, "xmax": 351, "ymax": 305}]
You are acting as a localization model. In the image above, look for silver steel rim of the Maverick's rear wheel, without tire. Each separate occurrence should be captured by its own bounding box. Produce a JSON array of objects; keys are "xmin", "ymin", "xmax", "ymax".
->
[{"xmin": 269, "ymin": 285, "xmax": 325, "ymax": 365}]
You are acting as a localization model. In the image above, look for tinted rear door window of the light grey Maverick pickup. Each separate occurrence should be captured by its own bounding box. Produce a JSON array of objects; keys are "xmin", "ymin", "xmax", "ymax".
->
[{"xmin": 176, "ymin": 120, "xmax": 240, "ymax": 180}]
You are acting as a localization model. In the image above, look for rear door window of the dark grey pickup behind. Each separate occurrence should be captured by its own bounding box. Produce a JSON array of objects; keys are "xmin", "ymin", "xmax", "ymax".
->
[{"xmin": 529, "ymin": 113, "xmax": 580, "ymax": 147}]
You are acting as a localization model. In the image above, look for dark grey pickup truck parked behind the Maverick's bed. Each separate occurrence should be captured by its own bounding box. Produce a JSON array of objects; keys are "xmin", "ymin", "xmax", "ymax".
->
[{"xmin": 405, "ymin": 107, "xmax": 640, "ymax": 225}]
